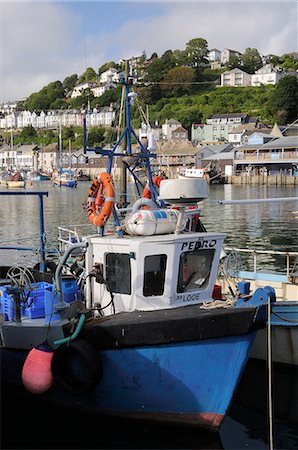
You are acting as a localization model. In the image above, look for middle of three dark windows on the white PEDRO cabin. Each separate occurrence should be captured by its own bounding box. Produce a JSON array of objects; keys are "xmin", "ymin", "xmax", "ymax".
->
[{"xmin": 143, "ymin": 255, "xmax": 167, "ymax": 297}]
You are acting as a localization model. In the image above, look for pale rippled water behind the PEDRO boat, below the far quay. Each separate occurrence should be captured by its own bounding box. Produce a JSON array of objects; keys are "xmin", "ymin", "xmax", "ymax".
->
[{"xmin": 0, "ymin": 181, "xmax": 298, "ymax": 268}]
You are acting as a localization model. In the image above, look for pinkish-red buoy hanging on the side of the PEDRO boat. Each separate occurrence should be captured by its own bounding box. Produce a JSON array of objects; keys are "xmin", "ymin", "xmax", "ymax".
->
[{"xmin": 22, "ymin": 344, "xmax": 54, "ymax": 394}]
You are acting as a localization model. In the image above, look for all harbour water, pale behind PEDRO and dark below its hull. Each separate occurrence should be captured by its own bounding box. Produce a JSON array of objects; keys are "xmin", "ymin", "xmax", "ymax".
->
[{"xmin": 0, "ymin": 181, "xmax": 298, "ymax": 450}]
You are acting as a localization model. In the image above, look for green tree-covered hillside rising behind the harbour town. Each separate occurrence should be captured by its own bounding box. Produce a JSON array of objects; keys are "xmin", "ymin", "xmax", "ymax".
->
[{"xmin": 16, "ymin": 38, "xmax": 298, "ymax": 128}]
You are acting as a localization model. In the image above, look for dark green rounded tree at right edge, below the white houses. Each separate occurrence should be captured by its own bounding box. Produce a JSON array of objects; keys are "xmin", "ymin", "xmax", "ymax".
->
[{"xmin": 269, "ymin": 75, "xmax": 298, "ymax": 124}]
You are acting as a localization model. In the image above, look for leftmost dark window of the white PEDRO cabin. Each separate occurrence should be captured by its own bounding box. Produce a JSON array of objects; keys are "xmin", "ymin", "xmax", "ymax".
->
[{"xmin": 106, "ymin": 253, "xmax": 131, "ymax": 295}]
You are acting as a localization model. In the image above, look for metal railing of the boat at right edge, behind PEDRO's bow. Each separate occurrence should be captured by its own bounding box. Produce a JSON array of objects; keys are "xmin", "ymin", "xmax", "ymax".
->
[{"xmin": 224, "ymin": 246, "xmax": 298, "ymax": 281}]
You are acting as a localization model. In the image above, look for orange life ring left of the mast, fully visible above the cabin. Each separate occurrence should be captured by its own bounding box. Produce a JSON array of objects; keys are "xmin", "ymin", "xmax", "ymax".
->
[{"xmin": 86, "ymin": 172, "xmax": 115, "ymax": 227}]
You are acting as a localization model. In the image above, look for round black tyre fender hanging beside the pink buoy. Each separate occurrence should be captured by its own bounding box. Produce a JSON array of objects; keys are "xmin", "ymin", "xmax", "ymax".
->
[{"xmin": 52, "ymin": 339, "xmax": 103, "ymax": 395}]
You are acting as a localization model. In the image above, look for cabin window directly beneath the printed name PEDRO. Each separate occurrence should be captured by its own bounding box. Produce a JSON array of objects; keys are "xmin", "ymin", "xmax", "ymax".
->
[{"xmin": 177, "ymin": 249, "xmax": 215, "ymax": 293}]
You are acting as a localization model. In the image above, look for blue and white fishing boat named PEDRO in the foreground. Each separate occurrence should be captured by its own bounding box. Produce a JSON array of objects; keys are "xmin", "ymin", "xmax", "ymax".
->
[{"xmin": 0, "ymin": 77, "xmax": 275, "ymax": 431}]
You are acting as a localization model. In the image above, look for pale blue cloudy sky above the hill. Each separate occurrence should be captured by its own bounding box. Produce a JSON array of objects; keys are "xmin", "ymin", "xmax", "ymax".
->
[{"xmin": 0, "ymin": 0, "xmax": 298, "ymax": 104}]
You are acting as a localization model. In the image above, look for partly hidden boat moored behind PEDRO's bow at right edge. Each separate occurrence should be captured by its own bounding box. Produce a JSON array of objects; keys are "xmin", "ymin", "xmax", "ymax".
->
[{"xmin": 217, "ymin": 247, "xmax": 298, "ymax": 369}]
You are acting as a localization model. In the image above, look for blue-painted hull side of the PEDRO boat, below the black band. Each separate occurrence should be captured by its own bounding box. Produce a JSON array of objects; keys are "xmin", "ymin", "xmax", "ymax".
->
[{"xmin": 2, "ymin": 332, "xmax": 255, "ymax": 431}]
